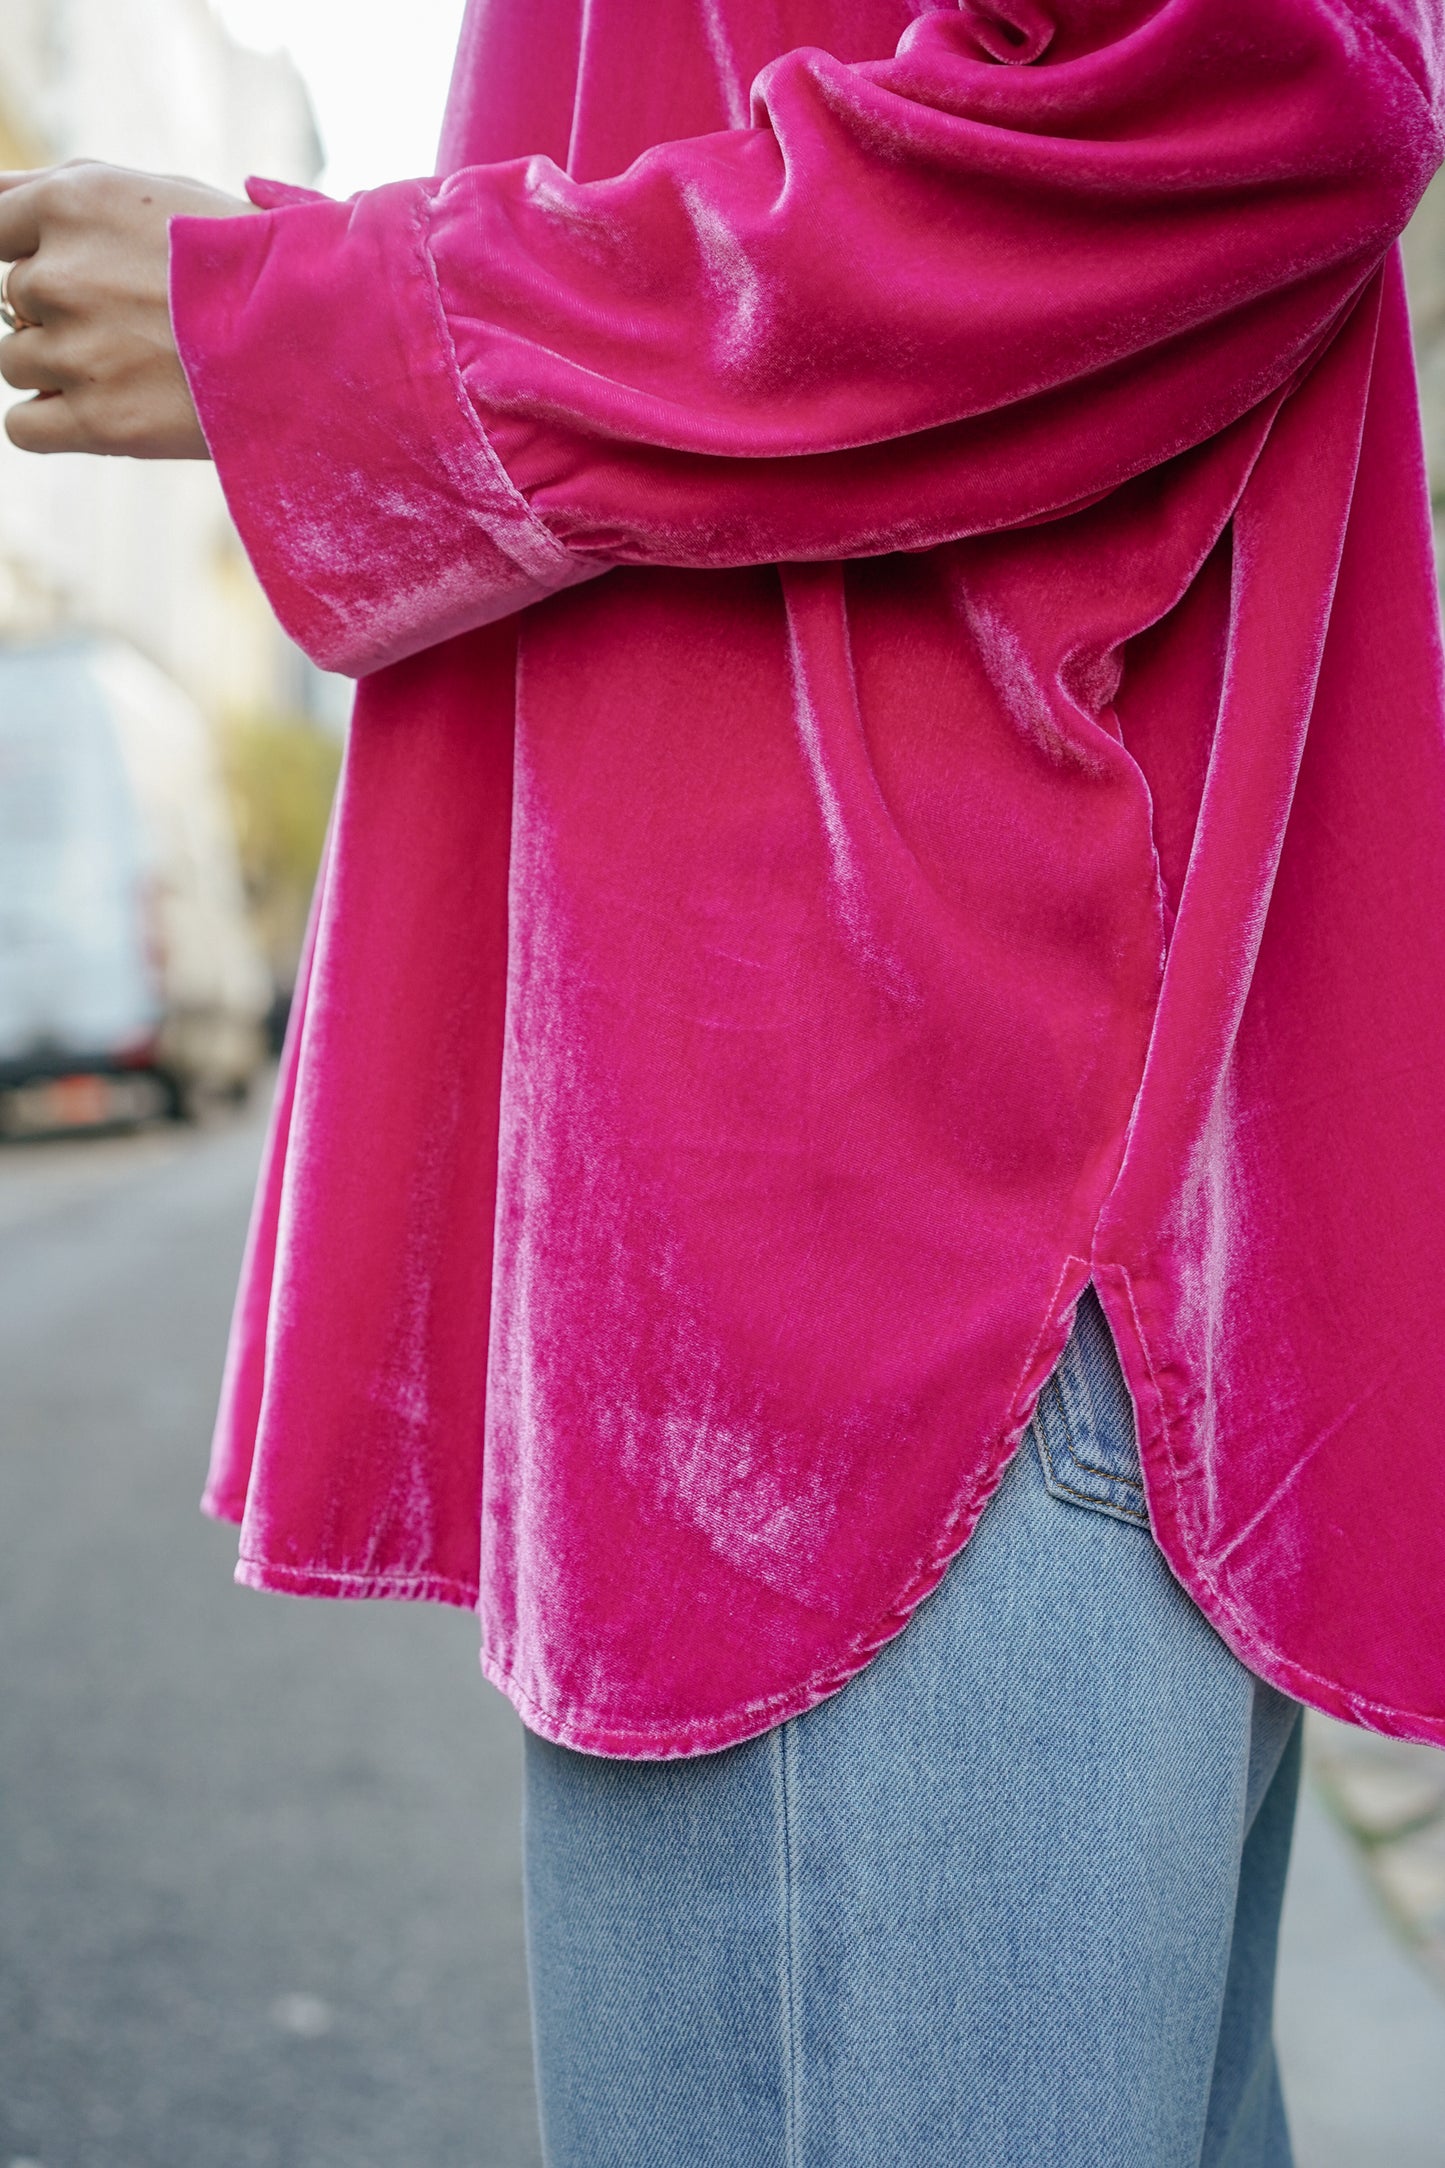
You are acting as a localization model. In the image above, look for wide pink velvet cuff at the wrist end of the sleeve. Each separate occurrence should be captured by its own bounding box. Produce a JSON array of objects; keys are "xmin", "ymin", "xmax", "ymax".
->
[{"xmin": 171, "ymin": 182, "xmax": 607, "ymax": 676}]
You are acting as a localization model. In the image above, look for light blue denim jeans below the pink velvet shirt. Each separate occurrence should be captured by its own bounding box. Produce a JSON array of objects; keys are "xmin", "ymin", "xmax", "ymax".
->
[{"xmin": 526, "ymin": 1294, "xmax": 1300, "ymax": 2168}]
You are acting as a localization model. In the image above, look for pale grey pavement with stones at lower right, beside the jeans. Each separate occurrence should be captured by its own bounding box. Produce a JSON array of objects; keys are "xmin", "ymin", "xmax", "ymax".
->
[{"xmin": 1278, "ymin": 1717, "xmax": 1445, "ymax": 2168}]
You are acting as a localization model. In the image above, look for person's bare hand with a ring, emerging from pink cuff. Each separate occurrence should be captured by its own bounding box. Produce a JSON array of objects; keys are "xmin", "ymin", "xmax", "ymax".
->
[{"xmin": 0, "ymin": 160, "xmax": 251, "ymax": 460}]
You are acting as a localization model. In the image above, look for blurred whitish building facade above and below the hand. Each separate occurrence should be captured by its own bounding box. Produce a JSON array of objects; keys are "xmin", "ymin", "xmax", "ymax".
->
[{"xmin": 0, "ymin": 0, "xmax": 334, "ymax": 718}]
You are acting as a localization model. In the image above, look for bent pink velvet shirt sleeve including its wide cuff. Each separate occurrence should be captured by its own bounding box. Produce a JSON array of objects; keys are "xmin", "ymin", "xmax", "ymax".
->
[{"xmin": 171, "ymin": 0, "xmax": 1441, "ymax": 674}]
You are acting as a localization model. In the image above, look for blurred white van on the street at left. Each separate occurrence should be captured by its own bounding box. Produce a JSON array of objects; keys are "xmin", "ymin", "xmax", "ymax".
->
[{"xmin": 0, "ymin": 637, "xmax": 271, "ymax": 1134}]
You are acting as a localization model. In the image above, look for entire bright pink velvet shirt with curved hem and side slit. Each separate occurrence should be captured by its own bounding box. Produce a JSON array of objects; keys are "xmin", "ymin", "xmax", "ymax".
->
[{"xmin": 173, "ymin": 0, "xmax": 1445, "ymax": 1756}]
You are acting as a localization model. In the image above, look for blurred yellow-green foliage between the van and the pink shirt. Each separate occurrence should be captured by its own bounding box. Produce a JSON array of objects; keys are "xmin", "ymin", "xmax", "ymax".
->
[{"xmin": 221, "ymin": 715, "xmax": 342, "ymax": 986}]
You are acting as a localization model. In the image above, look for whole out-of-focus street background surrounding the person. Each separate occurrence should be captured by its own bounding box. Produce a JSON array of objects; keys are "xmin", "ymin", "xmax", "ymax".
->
[{"xmin": 0, "ymin": 0, "xmax": 1445, "ymax": 2168}]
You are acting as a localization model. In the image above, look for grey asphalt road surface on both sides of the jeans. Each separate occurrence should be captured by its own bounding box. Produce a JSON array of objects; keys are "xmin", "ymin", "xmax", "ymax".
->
[{"xmin": 0, "ymin": 1117, "xmax": 1445, "ymax": 2168}]
